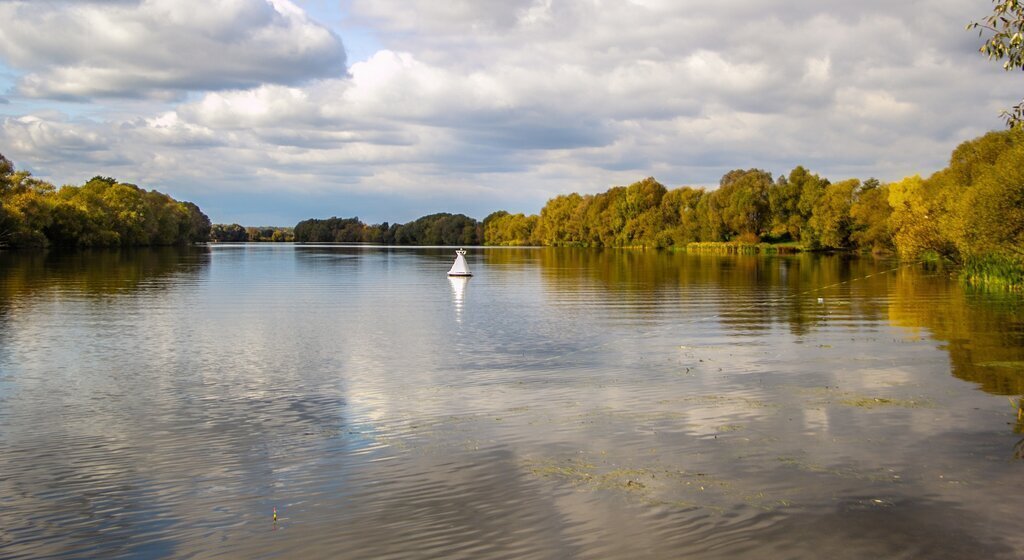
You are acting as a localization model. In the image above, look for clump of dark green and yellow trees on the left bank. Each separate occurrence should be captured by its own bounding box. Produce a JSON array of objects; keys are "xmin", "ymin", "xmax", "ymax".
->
[{"xmin": 0, "ymin": 155, "xmax": 210, "ymax": 247}]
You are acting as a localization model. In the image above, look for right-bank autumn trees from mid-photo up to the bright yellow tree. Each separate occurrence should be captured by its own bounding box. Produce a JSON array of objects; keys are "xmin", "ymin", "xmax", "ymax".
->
[{"xmin": 483, "ymin": 167, "xmax": 893, "ymax": 251}]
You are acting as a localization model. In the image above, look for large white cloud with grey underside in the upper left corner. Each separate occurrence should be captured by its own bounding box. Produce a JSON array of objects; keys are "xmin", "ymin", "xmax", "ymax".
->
[{"xmin": 0, "ymin": 0, "xmax": 345, "ymax": 99}]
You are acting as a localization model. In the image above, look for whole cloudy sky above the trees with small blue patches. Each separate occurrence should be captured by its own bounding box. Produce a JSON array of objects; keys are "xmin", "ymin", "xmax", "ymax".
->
[{"xmin": 0, "ymin": 0, "xmax": 1024, "ymax": 225}]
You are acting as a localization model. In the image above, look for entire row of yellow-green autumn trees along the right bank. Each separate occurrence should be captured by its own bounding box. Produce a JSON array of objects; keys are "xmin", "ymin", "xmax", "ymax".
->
[{"xmin": 483, "ymin": 127, "xmax": 1024, "ymax": 288}]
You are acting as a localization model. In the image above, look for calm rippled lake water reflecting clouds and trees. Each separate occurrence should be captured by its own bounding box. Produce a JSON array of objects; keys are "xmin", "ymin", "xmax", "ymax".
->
[{"xmin": 0, "ymin": 245, "xmax": 1024, "ymax": 559}]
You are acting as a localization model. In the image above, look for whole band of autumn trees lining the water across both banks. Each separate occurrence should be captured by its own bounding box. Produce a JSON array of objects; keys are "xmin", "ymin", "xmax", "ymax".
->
[{"xmin": 0, "ymin": 127, "xmax": 1024, "ymax": 290}]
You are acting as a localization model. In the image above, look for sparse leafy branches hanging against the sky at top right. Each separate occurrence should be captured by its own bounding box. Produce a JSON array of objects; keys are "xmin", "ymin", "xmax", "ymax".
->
[{"xmin": 967, "ymin": 0, "xmax": 1024, "ymax": 128}]
